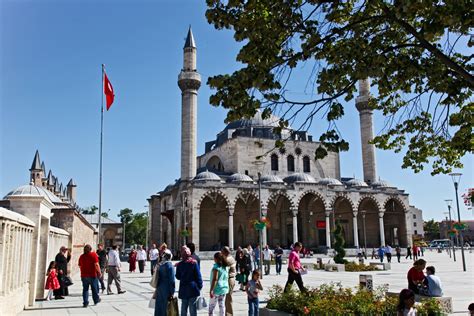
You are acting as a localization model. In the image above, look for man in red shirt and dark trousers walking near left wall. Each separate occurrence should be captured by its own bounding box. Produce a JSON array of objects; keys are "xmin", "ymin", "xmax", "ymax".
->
[{"xmin": 79, "ymin": 245, "xmax": 101, "ymax": 307}]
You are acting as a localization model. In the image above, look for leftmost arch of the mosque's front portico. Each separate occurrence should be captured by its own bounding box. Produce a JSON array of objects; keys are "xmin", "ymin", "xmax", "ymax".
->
[{"xmin": 198, "ymin": 190, "xmax": 230, "ymax": 251}]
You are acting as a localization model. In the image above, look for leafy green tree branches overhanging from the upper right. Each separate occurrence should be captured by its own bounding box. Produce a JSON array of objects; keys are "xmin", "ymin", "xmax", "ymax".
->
[{"xmin": 206, "ymin": 0, "xmax": 474, "ymax": 174}]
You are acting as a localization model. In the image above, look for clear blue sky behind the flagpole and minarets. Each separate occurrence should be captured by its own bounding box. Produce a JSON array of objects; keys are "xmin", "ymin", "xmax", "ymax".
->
[{"xmin": 0, "ymin": 0, "xmax": 473, "ymax": 219}]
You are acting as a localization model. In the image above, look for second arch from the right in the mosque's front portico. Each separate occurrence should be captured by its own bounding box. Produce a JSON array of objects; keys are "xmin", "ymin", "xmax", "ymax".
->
[{"xmin": 357, "ymin": 196, "xmax": 381, "ymax": 248}]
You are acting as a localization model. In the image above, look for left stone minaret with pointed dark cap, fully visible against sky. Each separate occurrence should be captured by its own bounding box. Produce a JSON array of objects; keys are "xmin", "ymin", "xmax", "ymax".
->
[{"xmin": 178, "ymin": 27, "xmax": 201, "ymax": 180}]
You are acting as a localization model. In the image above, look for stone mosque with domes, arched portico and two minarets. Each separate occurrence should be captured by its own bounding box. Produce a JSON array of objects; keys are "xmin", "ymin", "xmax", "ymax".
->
[{"xmin": 148, "ymin": 29, "xmax": 421, "ymax": 252}]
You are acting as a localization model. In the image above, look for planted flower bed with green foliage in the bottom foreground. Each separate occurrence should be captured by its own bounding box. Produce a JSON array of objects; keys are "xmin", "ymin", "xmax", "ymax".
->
[{"xmin": 267, "ymin": 283, "xmax": 441, "ymax": 315}]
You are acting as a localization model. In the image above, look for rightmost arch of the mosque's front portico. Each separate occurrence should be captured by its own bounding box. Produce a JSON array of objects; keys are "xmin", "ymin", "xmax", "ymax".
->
[{"xmin": 383, "ymin": 197, "xmax": 408, "ymax": 247}]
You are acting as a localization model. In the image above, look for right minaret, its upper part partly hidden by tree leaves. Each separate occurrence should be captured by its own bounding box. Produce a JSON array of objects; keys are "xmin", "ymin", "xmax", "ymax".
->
[{"xmin": 356, "ymin": 79, "xmax": 377, "ymax": 184}]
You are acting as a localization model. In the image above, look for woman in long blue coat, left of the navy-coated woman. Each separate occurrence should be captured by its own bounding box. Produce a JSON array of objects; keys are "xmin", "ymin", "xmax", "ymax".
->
[{"xmin": 155, "ymin": 252, "xmax": 175, "ymax": 316}]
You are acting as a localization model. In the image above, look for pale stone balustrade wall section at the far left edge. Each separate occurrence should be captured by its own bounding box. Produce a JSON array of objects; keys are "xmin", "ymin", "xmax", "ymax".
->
[{"xmin": 0, "ymin": 207, "xmax": 35, "ymax": 315}]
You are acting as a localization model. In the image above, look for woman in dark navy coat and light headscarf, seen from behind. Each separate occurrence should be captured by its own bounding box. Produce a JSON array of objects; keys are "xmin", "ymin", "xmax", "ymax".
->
[{"xmin": 176, "ymin": 246, "xmax": 202, "ymax": 316}]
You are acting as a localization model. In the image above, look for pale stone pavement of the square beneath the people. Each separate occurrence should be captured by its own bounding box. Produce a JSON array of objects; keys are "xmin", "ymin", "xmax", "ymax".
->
[{"xmin": 20, "ymin": 251, "xmax": 474, "ymax": 316}]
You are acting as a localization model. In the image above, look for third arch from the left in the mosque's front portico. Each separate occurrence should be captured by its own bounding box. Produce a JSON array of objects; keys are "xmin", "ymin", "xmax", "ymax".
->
[{"xmin": 267, "ymin": 194, "xmax": 293, "ymax": 247}]
